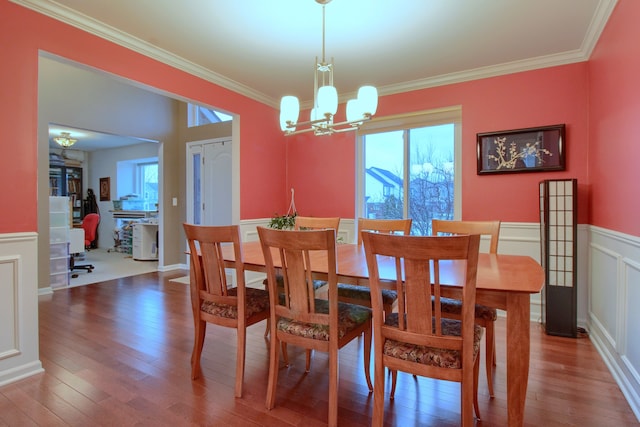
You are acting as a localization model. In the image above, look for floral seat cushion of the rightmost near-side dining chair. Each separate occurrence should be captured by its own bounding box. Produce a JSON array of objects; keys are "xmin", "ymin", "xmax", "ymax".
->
[{"xmin": 383, "ymin": 313, "xmax": 483, "ymax": 369}]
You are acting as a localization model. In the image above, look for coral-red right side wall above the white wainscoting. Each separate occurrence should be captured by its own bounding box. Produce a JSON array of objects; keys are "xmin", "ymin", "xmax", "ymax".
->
[{"xmin": 588, "ymin": 0, "xmax": 640, "ymax": 236}]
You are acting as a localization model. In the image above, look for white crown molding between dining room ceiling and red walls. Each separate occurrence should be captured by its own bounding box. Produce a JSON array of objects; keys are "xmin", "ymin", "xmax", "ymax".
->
[{"xmin": 10, "ymin": 0, "xmax": 618, "ymax": 108}]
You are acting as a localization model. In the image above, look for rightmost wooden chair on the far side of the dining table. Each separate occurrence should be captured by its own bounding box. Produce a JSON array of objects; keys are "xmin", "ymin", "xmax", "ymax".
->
[{"xmin": 431, "ymin": 219, "xmax": 500, "ymax": 397}]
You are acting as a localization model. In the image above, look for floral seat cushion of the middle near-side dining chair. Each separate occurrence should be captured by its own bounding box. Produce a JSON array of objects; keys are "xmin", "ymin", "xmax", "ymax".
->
[{"xmin": 277, "ymin": 299, "xmax": 371, "ymax": 341}]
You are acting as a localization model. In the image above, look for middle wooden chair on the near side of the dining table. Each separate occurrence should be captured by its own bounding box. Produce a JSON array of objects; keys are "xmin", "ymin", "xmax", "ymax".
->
[{"xmin": 258, "ymin": 227, "xmax": 373, "ymax": 426}]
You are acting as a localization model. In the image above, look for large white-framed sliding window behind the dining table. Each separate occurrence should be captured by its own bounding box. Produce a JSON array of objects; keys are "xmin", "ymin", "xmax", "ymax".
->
[{"xmin": 356, "ymin": 107, "xmax": 461, "ymax": 235}]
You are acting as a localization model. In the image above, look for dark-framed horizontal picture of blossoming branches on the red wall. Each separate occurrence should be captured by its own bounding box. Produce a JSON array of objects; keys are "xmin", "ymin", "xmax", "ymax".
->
[{"xmin": 477, "ymin": 124, "xmax": 566, "ymax": 175}]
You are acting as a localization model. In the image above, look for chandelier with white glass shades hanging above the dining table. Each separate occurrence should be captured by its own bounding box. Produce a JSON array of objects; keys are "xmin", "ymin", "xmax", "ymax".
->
[{"xmin": 280, "ymin": 0, "xmax": 378, "ymax": 135}]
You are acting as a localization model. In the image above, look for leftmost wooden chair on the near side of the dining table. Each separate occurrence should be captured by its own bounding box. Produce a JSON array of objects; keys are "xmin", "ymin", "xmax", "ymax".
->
[{"xmin": 183, "ymin": 223, "xmax": 269, "ymax": 397}]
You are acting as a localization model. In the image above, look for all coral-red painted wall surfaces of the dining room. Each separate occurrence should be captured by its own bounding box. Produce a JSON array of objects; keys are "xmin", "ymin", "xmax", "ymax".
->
[{"xmin": 0, "ymin": 0, "xmax": 640, "ymax": 235}]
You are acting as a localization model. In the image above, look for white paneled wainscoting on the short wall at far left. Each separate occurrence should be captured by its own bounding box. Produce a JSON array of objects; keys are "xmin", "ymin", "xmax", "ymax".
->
[{"xmin": 0, "ymin": 233, "xmax": 43, "ymax": 386}]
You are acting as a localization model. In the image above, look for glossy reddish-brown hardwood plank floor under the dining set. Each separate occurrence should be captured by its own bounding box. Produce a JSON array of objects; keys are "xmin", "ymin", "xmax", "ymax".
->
[{"xmin": 0, "ymin": 272, "xmax": 639, "ymax": 427}]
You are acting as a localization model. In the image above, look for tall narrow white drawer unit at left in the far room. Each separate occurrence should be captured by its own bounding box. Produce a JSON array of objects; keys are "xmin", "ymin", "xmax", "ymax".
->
[{"xmin": 49, "ymin": 196, "xmax": 71, "ymax": 289}]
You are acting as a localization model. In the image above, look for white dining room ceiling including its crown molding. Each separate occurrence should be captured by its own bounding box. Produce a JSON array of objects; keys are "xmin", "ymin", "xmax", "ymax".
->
[{"xmin": 28, "ymin": 0, "xmax": 617, "ymax": 150}]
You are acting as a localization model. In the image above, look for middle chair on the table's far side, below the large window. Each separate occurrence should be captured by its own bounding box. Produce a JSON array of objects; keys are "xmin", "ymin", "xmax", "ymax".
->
[{"xmin": 338, "ymin": 218, "xmax": 411, "ymax": 314}]
